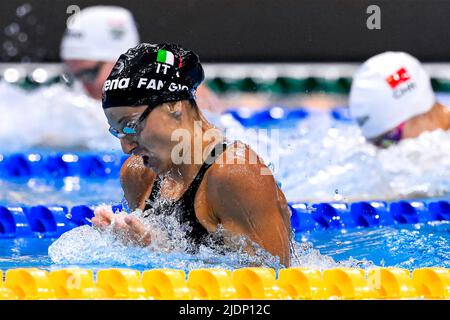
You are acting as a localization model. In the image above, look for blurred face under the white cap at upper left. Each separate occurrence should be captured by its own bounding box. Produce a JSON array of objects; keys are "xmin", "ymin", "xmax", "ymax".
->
[{"xmin": 64, "ymin": 60, "xmax": 114, "ymax": 100}]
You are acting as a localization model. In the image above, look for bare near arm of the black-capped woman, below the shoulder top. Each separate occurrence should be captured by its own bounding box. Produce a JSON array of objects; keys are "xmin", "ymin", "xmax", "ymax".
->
[{"xmin": 207, "ymin": 164, "xmax": 290, "ymax": 265}]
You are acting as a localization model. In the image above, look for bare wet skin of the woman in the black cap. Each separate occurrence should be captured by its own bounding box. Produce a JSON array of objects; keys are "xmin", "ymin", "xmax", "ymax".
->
[{"xmin": 92, "ymin": 101, "xmax": 291, "ymax": 266}]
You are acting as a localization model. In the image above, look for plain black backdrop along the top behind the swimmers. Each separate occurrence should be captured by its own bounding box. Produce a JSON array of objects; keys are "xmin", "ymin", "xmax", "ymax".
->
[{"xmin": 0, "ymin": 0, "xmax": 450, "ymax": 62}]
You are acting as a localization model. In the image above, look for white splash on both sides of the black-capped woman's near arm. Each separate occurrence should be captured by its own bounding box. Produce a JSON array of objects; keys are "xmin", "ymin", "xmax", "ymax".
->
[{"xmin": 48, "ymin": 204, "xmax": 376, "ymax": 270}]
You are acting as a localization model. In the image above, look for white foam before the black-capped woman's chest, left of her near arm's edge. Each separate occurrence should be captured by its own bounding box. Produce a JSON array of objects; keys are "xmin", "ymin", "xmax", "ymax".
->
[{"xmin": 48, "ymin": 200, "xmax": 281, "ymax": 270}]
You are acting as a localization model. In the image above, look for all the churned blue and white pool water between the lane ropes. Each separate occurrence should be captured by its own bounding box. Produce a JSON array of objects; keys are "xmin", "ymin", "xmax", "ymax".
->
[{"xmin": 0, "ymin": 83, "xmax": 450, "ymax": 270}]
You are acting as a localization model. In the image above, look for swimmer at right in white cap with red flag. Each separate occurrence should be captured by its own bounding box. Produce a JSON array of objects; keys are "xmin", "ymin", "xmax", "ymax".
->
[{"xmin": 349, "ymin": 52, "xmax": 450, "ymax": 147}]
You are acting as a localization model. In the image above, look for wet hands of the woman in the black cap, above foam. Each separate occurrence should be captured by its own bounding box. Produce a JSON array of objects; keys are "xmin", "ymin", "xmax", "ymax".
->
[{"xmin": 91, "ymin": 207, "xmax": 151, "ymax": 247}]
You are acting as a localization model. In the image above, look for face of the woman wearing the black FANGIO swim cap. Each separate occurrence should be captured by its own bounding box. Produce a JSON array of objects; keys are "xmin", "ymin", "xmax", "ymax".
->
[{"xmin": 105, "ymin": 104, "xmax": 184, "ymax": 174}]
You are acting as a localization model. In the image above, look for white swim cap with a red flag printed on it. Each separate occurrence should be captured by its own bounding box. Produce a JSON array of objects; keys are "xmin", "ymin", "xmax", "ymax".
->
[{"xmin": 349, "ymin": 52, "xmax": 435, "ymax": 139}]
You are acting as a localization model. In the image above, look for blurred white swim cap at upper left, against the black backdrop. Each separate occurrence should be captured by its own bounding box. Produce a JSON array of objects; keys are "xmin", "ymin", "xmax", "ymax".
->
[{"xmin": 60, "ymin": 6, "xmax": 139, "ymax": 61}]
